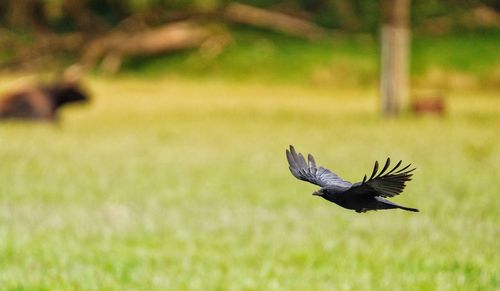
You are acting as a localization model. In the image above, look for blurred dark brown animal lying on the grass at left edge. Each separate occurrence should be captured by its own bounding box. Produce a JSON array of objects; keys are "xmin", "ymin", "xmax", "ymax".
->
[{"xmin": 0, "ymin": 81, "xmax": 89, "ymax": 120}]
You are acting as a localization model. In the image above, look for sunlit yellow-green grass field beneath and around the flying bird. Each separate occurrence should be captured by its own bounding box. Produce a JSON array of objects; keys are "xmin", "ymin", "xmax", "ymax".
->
[{"xmin": 0, "ymin": 78, "xmax": 500, "ymax": 290}]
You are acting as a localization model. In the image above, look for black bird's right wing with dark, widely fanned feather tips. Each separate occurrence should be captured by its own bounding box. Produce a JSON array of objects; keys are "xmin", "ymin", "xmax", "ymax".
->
[{"xmin": 351, "ymin": 158, "xmax": 415, "ymax": 197}]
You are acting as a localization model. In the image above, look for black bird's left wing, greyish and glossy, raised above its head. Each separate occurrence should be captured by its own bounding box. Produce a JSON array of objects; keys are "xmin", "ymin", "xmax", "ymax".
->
[{"xmin": 286, "ymin": 146, "xmax": 352, "ymax": 188}]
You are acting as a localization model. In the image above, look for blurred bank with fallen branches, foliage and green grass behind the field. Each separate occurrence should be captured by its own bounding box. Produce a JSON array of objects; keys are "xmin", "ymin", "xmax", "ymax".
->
[{"xmin": 0, "ymin": 0, "xmax": 500, "ymax": 89}]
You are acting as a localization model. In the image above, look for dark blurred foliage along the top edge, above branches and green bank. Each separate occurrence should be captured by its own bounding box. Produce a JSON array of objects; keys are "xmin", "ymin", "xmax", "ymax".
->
[{"xmin": 0, "ymin": 0, "xmax": 500, "ymax": 32}]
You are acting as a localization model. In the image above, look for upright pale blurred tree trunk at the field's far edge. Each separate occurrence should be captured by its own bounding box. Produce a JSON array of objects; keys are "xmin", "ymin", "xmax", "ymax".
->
[{"xmin": 380, "ymin": 0, "xmax": 410, "ymax": 116}]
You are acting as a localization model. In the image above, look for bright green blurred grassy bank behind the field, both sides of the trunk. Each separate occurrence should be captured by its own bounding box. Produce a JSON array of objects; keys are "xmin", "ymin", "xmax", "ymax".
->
[{"xmin": 120, "ymin": 28, "xmax": 500, "ymax": 89}]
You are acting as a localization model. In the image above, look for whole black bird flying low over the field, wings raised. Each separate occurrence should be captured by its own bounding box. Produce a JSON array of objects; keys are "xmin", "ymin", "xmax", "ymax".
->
[{"xmin": 286, "ymin": 146, "xmax": 418, "ymax": 213}]
